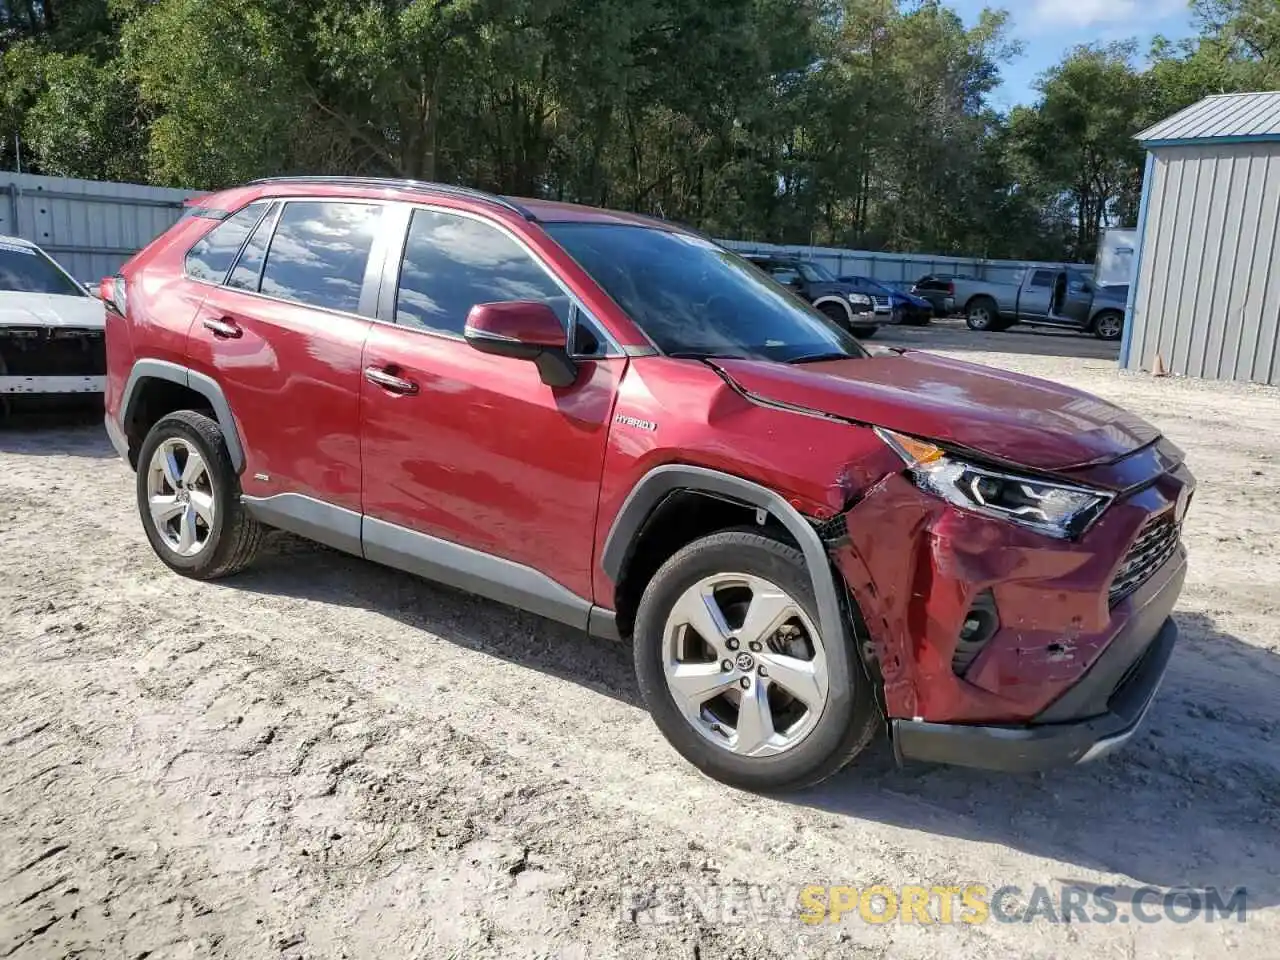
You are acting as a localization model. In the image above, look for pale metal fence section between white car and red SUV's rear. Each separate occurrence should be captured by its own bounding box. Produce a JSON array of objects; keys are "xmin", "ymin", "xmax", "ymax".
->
[{"xmin": 0, "ymin": 173, "xmax": 196, "ymax": 280}]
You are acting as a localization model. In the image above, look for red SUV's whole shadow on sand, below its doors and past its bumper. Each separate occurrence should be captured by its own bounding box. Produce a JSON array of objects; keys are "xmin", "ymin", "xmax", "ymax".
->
[{"xmin": 227, "ymin": 535, "xmax": 1280, "ymax": 910}]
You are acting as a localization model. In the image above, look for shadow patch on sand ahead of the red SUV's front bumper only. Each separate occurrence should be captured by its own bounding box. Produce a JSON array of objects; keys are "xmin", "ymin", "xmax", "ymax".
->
[{"xmin": 796, "ymin": 613, "xmax": 1280, "ymax": 910}]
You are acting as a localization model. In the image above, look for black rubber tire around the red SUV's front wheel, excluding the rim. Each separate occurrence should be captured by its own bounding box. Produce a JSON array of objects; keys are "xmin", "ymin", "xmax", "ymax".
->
[{"xmin": 634, "ymin": 530, "xmax": 879, "ymax": 792}]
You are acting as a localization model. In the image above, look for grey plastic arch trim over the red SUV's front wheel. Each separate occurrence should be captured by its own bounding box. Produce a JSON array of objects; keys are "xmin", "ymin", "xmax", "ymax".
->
[{"xmin": 600, "ymin": 463, "xmax": 844, "ymax": 655}]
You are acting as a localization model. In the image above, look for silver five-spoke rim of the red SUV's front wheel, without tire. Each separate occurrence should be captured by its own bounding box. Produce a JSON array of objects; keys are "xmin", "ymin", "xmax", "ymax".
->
[{"xmin": 663, "ymin": 573, "xmax": 828, "ymax": 756}]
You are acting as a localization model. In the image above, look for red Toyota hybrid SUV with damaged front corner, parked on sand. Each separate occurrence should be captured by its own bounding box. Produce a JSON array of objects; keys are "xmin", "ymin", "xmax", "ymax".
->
[{"xmin": 102, "ymin": 178, "xmax": 1194, "ymax": 790}]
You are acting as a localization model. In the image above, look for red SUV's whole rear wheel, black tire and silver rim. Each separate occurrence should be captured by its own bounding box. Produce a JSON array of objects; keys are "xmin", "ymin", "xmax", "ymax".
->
[{"xmin": 137, "ymin": 410, "xmax": 264, "ymax": 580}]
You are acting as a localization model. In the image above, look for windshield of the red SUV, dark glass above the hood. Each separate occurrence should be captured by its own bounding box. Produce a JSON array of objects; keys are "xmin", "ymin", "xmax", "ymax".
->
[{"xmin": 544, "ymin": 223, "xmax": 867, "ymax": 362}]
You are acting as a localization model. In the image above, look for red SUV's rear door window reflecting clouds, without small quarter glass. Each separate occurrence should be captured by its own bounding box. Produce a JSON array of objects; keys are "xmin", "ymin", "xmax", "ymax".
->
[{"xmin": 261, "ymin": 200, "xmax": 381, "ymax": 312}]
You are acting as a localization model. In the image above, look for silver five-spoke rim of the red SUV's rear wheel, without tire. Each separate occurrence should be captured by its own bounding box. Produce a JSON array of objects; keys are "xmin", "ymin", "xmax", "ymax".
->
[{"xmin": 147, "ymin": 436, "xmax": 218, "ymax": 557}]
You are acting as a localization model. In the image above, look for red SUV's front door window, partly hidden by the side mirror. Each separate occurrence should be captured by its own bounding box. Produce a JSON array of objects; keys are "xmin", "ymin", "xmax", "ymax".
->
[{"xmin": 396, "ymin": 210, "xmax": 571, "ymax": 337}]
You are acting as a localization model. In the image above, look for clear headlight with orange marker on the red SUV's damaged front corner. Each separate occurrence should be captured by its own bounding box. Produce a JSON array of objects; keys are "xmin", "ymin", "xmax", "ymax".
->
[{"xmin": 876, "ymin": 428, "xmax": 1112, "ymax": 540}]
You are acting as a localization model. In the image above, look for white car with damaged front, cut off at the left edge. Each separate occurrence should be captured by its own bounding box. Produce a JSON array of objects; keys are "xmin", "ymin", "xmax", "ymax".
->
[{"xmin": 0, "ymin": 237, "xmax": 106, "ymax": 406}]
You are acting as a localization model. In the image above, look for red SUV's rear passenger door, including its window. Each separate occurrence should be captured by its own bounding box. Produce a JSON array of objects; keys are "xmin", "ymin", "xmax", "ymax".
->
[{"xmin": 188, "ymin": 198, "xmax": 384, "ymax": 527}]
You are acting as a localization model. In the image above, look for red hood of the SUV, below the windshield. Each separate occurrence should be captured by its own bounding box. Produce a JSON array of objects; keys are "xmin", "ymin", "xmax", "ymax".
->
[{"xmin": 712, "ymin": 351, "xmax": 1160, "ymax": 471}]
